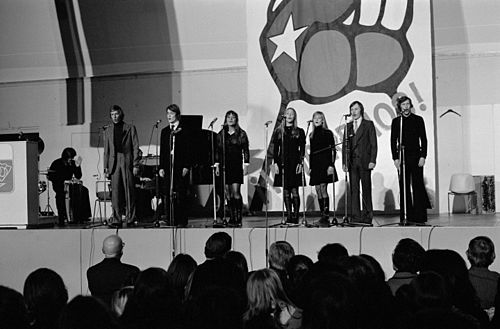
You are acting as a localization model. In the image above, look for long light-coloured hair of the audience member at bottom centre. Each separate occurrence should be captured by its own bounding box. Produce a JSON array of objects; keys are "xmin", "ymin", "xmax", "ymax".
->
[{"xmin": 243, "ymin": 268, "xmax": 294, "ymax": 321}]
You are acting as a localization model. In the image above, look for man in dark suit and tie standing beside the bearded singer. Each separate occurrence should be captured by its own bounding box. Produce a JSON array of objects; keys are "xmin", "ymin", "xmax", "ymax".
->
[{"xmin": 342, "ymin": 101, "xmax": 377, "ymax": 224}]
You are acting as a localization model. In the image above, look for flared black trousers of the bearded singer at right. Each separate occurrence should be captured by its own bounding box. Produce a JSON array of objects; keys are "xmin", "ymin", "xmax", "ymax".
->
[{"xmin": 399, "ymin": 156, "xmax": 430, "ymax": 223}]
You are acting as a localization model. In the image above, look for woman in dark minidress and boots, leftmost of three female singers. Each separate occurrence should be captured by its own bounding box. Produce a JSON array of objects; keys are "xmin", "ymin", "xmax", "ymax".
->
[{"xmin": 216, "ymin": 110, "xmax": 250, "ymax": 226}]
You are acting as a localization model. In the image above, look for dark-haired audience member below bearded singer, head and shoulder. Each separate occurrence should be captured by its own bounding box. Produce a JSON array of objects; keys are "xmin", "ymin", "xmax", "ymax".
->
[{"xmin": 387, "ymin": 238, "xmax": 425, "ymax": 295}]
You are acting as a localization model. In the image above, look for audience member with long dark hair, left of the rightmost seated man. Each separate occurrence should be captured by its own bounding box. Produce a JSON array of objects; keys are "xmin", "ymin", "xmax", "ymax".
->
[{"xmin": 421, "ymin": 249, "xmax": 489, "ymax": 328}]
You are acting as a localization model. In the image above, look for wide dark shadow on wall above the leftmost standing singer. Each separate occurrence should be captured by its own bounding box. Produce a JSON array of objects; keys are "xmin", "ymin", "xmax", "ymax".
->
[{"xmin": 79, "ymin": 0, "xmax": 180, "ymax": 147}]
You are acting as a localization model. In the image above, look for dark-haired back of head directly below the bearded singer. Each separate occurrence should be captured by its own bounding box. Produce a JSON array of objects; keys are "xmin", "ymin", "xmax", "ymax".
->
[{"xmin": 392, "ymin": 238, "xmax": 425, "ymax": 273}]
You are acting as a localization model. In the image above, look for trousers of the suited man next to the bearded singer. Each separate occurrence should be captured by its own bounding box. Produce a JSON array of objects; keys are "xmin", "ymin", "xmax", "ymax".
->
[{"xmin": 349, "ymin": 158, "xmax": 373, "ymax": 223}]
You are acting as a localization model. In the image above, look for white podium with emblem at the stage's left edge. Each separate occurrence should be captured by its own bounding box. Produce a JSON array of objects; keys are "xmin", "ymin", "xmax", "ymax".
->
[{"xmin": 0, "ymin": 141, "xmax": 39, "ymax": 228}]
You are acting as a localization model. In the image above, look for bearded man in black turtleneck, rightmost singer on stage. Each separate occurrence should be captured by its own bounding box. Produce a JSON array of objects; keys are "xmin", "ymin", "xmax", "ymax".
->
[{"xmin": 391, "ymin": 96, "xmax": 430, "ymax": 223}]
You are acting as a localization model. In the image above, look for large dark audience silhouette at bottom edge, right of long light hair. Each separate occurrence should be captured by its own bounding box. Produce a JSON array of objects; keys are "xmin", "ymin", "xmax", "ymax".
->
[{"xmin": 302, "ymin": 272, "xmax": 363, "ymax": 329}]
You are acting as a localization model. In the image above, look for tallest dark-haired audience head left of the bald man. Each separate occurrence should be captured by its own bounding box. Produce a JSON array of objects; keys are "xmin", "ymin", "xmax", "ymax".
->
[{"xmin": 23, "ymin": 268, "xmax": 68, "ymax": 329}]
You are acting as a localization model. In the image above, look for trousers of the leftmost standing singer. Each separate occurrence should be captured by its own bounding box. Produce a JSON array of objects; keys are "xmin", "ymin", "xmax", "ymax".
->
[{"xmin": 111, "ymin": 153, "xmax": 135, "ymax": 223}]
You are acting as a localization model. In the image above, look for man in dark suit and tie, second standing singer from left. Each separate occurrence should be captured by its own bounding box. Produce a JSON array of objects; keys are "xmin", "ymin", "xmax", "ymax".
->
[{"xmin": 159, "ymin": 104, "xmax": 193, "ymax": 227}]
